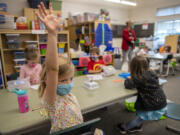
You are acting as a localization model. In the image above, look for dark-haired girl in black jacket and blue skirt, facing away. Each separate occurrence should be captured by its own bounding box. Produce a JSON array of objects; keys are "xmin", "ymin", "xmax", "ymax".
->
[{"xmin": 117, "ymin": 56, "xmax": 167, "ymax": 134}]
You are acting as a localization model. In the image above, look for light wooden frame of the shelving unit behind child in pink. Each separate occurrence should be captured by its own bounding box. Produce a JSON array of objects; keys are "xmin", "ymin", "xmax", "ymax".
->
[{"xmin": 0, "ymin": 29, "xmax": 70, "ymax": 86}]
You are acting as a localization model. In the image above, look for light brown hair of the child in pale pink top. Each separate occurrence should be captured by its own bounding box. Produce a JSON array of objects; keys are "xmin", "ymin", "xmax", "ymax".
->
[{"xmin": 24, "ymin": 47, "xmax": 39, "ymax": 60}]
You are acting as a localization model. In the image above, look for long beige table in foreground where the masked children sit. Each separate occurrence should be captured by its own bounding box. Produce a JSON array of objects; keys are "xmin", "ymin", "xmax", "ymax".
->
[{"xmin": 0, "ymin": 71, "xmax": 137, "ymax": 135}]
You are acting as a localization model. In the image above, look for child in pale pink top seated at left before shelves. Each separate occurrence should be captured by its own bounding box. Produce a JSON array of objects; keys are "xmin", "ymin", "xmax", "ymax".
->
[{"xmin": 20, "ymin": 48, "xmax": 42, "ymax": 84}]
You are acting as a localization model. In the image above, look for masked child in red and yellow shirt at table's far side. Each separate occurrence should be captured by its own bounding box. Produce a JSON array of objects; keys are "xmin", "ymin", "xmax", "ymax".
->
[{"xmin": 87, "ymin": 47, "xmax": 104, "ymax": 74}]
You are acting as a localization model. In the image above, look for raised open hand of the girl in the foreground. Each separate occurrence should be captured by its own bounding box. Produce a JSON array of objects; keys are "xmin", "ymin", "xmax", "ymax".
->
[{"xmin": 36, "ymin": 2, "xmax": 60, "ymax": 33}]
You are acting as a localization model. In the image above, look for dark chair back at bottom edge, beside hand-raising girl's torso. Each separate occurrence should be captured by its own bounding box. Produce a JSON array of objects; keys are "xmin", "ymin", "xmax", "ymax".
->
[{"xmin": 50, "ymin": 118, "xmax": 101, "ymax": 135}]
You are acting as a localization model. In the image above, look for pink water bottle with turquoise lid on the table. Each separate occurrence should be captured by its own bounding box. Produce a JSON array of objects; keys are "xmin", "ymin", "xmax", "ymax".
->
[{"xmin": 12, "ymin": 88, "xmax": 29, "ymax": 113}]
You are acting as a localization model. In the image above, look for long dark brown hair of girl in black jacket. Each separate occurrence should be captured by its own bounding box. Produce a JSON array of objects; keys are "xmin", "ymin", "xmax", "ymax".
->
[{"xmin": 130, "ymin": 56, "xmax": 150, "ymax": 78}]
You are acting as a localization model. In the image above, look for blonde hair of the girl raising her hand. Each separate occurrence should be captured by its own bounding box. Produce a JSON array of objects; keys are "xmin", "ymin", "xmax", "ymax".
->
[{"xmin": 38, "ymin": 57, "xmax": 74, "ymax": 98}]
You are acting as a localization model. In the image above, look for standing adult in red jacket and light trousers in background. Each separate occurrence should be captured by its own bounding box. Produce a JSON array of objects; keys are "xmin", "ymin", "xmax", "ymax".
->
[{"xmin": 120, "ymin": 21, "xmax": 136, "ymax": 70}]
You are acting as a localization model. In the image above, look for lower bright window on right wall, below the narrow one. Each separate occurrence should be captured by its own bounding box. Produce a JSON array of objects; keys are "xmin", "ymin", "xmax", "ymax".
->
[{"xmin": 155, "ymin": 20, "xmax": 180, "ymax": 45}]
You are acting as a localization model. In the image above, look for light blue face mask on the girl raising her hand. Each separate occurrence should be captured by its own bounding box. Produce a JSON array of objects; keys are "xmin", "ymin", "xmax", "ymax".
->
[{"xmin": 57, "ymin": 82, "xmax": 73, "ymax": 96}]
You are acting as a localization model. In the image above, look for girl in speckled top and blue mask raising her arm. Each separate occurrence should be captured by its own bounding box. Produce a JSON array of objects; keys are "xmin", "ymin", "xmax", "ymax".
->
[{"xmin": 37, "ymin": 3, "xmax": 83, "ymax": 133}]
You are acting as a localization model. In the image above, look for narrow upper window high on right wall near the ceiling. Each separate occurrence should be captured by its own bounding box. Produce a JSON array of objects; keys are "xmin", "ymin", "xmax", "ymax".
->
[{"xmin": 156, "ymin": 5, "xmax": 180, "ymax": 16}]
